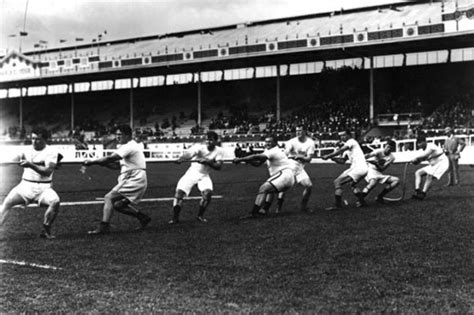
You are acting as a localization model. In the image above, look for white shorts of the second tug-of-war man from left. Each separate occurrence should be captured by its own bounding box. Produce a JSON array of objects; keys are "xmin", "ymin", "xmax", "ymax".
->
[{"xmin": 112, "ymin": 169, "xmax": 148, "ymax": 204}]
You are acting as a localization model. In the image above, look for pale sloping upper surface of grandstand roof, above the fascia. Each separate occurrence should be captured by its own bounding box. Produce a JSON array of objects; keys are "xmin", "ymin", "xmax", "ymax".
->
[{"xmin": 28, "ymin": 2, "xmax": 455, "ymax": 65}]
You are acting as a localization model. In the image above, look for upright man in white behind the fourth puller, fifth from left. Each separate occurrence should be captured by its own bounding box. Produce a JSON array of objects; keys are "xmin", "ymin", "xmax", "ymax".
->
[{"xmin": 277, "ymin": 125, "xmax": 315, "ymax": 213}]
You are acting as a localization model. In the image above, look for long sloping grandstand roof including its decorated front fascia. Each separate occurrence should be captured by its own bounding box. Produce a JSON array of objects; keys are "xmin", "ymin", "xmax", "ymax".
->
[{"xmin": 0, "ymin": 1, "xmax": 474, "ymax": 88}]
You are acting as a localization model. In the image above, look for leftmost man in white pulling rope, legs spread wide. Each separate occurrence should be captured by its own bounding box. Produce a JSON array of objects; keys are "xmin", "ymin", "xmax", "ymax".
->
[{"xmin": 0, "ymin": 128, "xmax": 60, "ymax": 239}]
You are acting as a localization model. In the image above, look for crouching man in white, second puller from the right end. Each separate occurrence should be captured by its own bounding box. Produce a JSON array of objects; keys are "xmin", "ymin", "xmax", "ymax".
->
[{"xmin": 356, "ymin": 140, "xmax": 400, "ymax": 207}]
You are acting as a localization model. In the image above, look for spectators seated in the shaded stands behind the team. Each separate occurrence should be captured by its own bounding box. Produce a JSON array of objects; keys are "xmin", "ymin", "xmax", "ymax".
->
[{"xmin": 3, "ymin": 95, "xmax": 472, "ymax": 148}]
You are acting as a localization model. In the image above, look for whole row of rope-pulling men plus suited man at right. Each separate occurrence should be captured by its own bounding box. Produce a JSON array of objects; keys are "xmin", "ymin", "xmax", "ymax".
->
[{"xmin": 0, "ymin": 125, "xmax": 464, "ymax": 239}]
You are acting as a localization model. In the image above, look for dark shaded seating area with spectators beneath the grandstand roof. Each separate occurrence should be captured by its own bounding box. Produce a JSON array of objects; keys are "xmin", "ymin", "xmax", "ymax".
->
[{"xmin": 3, "ymin": 65, "xmax": 474, "ymax": 146}]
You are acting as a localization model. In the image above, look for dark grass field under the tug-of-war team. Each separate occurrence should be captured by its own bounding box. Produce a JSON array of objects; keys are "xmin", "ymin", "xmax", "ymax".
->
[{"xmin": 0, "ymin": 164, "xmax": 474, "ymax": 314}]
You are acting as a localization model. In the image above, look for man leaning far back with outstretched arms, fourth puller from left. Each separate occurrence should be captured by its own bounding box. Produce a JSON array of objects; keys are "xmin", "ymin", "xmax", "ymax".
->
[{"xmin": 233, "ymin": 135, "xmax": 297, "ymax": 218}]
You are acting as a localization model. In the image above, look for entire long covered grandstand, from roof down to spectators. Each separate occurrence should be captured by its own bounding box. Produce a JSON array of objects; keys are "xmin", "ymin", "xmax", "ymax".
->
[{"xmin": 0, "ymin": 1, "xmax": 474, "ymax": 144}]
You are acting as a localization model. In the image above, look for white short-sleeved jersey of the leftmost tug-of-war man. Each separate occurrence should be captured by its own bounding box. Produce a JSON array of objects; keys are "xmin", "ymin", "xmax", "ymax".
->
[{"xmin": 22, "ymin": 145, "xmax": 58, "ymax": 182}]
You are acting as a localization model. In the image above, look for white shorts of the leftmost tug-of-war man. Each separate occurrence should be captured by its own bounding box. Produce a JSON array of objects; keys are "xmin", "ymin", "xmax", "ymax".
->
[{"xmin": 6, "ymin": 180, "xmax": 59, "ymax": 205}]
